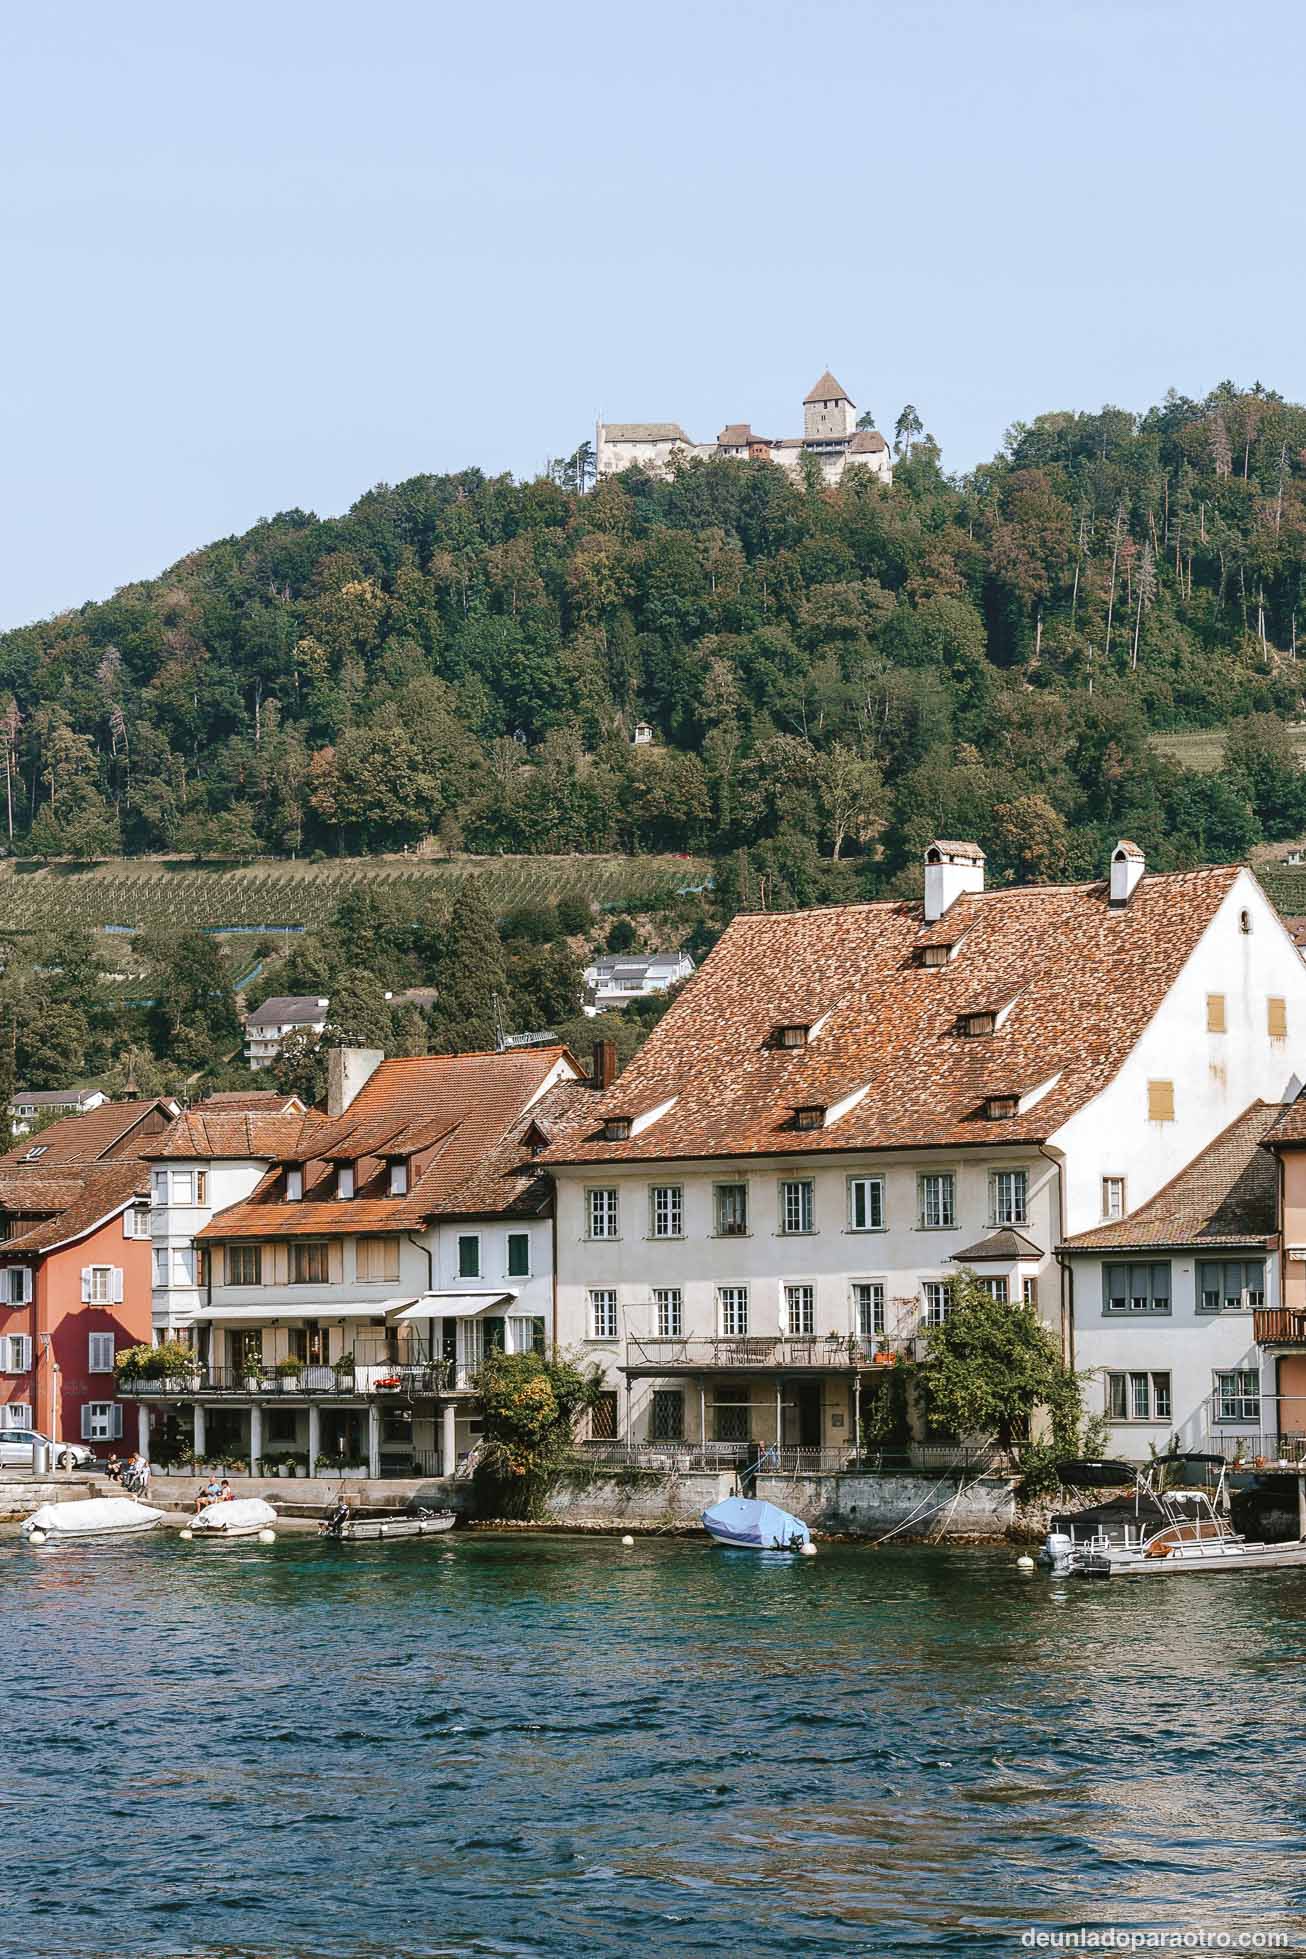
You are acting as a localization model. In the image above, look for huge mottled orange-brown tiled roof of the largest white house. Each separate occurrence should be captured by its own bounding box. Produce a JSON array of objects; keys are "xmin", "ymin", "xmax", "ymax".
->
[{"xmin": 546, "ymin": 866, "xmax": 1239, "ymax": 1164}]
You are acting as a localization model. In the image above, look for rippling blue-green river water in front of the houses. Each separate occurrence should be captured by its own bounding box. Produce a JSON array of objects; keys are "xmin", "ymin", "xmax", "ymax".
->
[{"xmin": 0, "ymin": 1536, "xmax": 1306, "ymax": 1959}]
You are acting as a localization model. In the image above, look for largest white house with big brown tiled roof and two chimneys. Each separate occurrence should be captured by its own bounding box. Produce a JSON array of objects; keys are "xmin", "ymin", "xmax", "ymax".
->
[{"xmin": 546, "ymin": 842, "xmax": 1306, "ymax": 1450}]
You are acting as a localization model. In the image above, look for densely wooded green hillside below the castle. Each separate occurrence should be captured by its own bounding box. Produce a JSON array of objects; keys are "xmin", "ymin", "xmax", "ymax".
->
[{"xmin": 0, "ymin": 384, "xmax": 1306, "ymax": 901}]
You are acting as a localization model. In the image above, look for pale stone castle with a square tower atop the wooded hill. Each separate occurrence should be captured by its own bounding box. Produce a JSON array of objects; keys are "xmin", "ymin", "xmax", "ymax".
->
[{"xmin": 593, "ymin": 368, "xmax": 893, "ymax": 484}]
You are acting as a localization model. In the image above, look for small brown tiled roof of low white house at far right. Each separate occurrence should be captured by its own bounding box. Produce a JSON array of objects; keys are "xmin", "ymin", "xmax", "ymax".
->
[{"xmin": 1063, "ymin": 1101, "xmax": 1283, "ymax": 1252}]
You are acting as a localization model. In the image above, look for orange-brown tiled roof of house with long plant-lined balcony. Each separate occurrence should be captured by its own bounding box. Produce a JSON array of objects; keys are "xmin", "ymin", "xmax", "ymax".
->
[{"xmin": 200, "ymin": 1046, "xmax": 593, "ymax": 1240}]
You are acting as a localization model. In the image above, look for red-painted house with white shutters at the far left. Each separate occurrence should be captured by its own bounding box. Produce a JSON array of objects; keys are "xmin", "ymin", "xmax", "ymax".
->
[{"xmin": 0, "ymin": 1101, "xmax": 176, "ymax": 1454}]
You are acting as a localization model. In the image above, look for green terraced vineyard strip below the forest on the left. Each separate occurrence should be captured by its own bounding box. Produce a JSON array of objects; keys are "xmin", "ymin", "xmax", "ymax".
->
[{"xmin": 0, "ymin": 856, "xmax": 711, "ymax": 932}]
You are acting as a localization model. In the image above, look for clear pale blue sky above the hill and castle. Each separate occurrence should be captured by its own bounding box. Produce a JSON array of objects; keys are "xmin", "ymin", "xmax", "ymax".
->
[{"xmin": 0, "ymin": 0, "xmax": 1306, "ymax": 625}]
